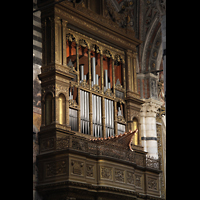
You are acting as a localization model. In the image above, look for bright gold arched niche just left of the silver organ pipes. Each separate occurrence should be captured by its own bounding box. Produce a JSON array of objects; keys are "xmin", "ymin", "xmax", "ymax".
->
[{"xmin": 58, "ymin": 93, "xmax": 66, "ymax": 124}]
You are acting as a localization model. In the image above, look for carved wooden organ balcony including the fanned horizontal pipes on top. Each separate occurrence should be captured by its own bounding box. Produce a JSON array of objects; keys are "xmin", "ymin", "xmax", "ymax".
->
[{"xmin": 37, "ymin": 130, "xmax": 161, "ymax": 199}]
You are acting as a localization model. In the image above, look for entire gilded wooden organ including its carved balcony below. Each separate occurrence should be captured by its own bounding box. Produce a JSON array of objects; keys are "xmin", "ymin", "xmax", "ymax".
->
[{"xmin": 36, "ymin": 0, "xmax": 166, "ymax": 200}]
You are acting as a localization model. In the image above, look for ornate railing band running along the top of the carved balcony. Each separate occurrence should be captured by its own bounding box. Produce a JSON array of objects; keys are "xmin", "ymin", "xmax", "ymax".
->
[{"xmin": 40, "ymin": 135, "xmax": 160, "ymax": 170}]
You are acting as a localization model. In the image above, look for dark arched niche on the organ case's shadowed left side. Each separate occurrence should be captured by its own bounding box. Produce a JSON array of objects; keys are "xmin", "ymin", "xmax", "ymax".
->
[{"xmin": 45, "ymin": 93, "xmax": 53, "ymax": 125}]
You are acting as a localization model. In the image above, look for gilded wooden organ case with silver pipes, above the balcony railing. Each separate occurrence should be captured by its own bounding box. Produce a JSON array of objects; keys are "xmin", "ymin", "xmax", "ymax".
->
[{"xmin": 39, "ymin": 1, "xmax": 143, "ymax": 142}]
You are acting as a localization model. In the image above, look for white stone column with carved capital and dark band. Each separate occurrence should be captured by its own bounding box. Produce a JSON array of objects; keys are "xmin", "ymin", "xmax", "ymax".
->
[{"xmin": 140, "ymin": 99, "xmax": 162, "ymax": 159}]
